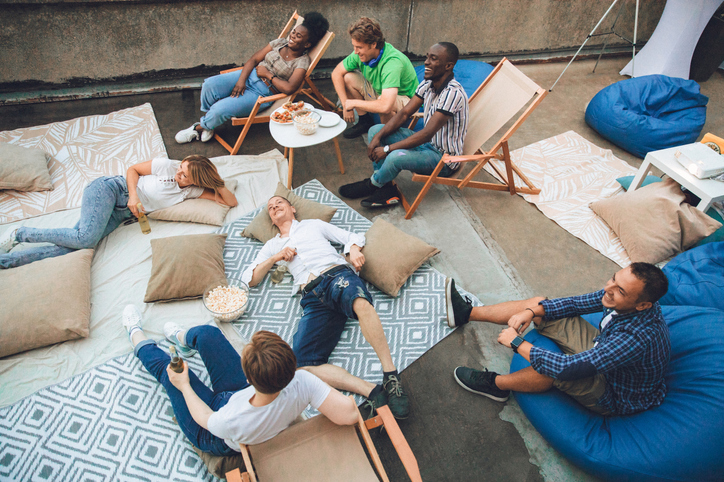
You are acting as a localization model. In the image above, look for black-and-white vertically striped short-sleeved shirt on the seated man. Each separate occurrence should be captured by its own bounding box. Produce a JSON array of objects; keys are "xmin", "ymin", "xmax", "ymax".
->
[{"xmin": 415, "ymin": 75, "xmax": 468, "ymax": 169}]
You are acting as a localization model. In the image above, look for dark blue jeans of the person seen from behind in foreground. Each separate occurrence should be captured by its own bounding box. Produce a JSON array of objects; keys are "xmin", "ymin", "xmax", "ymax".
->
[{"xmin": 134, "ymin": 325, "xmax": 249, "ymax": 455}]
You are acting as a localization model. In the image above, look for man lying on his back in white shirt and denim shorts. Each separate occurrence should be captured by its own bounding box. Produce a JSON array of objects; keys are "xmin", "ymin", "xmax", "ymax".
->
[{"xmin": 242, "ymin": 196, "xmax": 410, "ymax": 419}]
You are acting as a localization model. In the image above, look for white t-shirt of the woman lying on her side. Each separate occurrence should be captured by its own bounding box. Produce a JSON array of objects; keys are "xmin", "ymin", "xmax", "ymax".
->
[{"xmin": 136, "ymin": 157, "xmax": 204, "ymax": 213}]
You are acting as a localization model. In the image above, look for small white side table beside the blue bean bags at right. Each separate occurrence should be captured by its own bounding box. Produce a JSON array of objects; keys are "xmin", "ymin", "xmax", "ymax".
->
[{"xmin": 629, "ymin": 144, "xmax": 724, "ymax": 212}]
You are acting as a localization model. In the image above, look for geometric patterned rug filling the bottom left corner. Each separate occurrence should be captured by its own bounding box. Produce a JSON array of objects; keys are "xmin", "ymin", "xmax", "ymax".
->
[{"xmin": 0, "ymin": 340, "xmax": 218, "ymax": 481}]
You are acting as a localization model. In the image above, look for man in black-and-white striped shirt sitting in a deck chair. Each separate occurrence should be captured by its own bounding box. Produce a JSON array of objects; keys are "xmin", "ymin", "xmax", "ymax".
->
[{"xmin": 339, "ymin": 42, "xmax": 468, "ymax": 207}]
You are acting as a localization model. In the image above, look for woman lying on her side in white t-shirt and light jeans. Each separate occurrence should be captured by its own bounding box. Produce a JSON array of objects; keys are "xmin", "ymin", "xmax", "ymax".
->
[{"xmin": 0, "ymin": 155, "xmax": 237, "ymax": 268}]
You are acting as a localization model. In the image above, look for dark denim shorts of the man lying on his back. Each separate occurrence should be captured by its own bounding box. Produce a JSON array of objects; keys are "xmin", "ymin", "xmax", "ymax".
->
[{"xmin": 292, "ymin": 266, "xmax": 372, "ymax": 367}]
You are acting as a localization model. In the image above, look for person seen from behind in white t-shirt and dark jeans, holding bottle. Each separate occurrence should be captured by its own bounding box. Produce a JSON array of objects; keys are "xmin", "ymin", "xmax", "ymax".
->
[{"xmin": 123, "ymin": 305, "xmax": 357, "ymax": 456}]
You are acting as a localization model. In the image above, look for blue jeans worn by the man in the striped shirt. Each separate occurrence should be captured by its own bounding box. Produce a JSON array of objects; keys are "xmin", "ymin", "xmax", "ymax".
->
[{"xmin": 367, "ymin": 124, "xmax": 455, "ymax": 187}]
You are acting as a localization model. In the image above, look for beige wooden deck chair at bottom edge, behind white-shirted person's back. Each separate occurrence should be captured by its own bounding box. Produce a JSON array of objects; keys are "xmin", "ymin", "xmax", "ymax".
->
[{"xmin": 226, "ymin": 406, "xmax": 422, "ymax": 482}]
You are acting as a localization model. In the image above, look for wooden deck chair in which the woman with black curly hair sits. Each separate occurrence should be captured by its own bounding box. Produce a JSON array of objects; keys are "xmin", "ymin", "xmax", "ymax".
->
[{"xmin": 214, "ymin": 10, "xmax": 337, "ymax": 156}]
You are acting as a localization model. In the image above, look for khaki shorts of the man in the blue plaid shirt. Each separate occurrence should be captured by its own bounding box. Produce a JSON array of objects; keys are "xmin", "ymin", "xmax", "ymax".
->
[{"xmin": 536, "ymin": 316, "xmax": 609, "ymax": 415}]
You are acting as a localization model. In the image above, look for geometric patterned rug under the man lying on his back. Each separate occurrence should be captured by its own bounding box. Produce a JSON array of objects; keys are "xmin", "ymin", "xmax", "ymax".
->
[{"xmin": 221, "ymin": 179, "xmax": 453, "ymax": 402}]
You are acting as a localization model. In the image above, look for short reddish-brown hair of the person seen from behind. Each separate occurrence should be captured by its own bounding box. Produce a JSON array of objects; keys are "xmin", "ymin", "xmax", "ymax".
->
[{"xmin": 241, "ymin": 330, "xmax": 297, "ymax": 395}]
